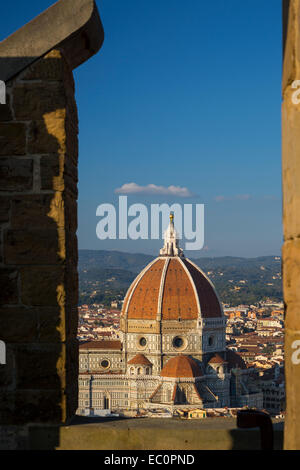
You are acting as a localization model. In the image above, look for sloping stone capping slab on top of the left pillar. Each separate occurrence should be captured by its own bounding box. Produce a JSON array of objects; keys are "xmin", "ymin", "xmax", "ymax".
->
[{"xmin": 0, "ymin": 0, "xmax": 104, "ymax": 81}]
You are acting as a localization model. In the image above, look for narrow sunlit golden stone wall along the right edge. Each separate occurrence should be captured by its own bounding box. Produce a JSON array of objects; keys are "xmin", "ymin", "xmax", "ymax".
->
[{"xmin": 282, "ymin": 0, "xmax": 300, "ymax": 449}]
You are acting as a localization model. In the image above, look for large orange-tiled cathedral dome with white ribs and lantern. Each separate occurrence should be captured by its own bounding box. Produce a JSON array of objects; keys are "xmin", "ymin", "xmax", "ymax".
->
[{"xmin": 122, "ymin": 214, "xmax": 223, "ymax": 321}]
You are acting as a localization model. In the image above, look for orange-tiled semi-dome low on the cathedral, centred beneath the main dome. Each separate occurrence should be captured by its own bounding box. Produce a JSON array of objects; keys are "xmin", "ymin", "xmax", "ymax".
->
[{"xmin": 160, "ymin": 355, "xmax": 203, "ymax": 378}]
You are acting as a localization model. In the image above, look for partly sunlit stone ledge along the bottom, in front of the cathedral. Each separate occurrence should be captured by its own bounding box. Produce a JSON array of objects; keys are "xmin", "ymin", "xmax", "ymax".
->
[{"xmin": 0, "ymin": 417, "xmax": 283, "ymax": 450}]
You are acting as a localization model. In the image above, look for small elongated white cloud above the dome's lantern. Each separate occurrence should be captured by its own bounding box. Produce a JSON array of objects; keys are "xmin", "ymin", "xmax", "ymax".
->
[{"xmin": 115, "ymin": 183, "xmax": 193, "ymax": 197}]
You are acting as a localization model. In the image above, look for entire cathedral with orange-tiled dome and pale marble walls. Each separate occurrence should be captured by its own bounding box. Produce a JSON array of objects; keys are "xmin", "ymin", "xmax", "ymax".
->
[{"xmin": 79, "ymin": 214, "xmax": 262, "ymax": 413}]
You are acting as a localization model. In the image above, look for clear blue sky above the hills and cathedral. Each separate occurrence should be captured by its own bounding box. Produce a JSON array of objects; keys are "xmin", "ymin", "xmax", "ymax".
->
[{"xmin": 0, "ymin": 0, "xmax": 282, "ymax": 257}]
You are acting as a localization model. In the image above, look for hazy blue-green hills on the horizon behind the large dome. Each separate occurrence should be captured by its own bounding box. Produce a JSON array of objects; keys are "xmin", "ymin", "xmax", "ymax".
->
[{"xmin": 78, "ymin": 250, "xmax": 282, "ymax": 305}]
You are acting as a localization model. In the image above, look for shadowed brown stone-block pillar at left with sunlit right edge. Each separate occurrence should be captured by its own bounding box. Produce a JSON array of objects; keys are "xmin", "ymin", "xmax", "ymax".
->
[{"xmin": 0, "ymin": 49, "xmax": 78, "ymax": 425}]
